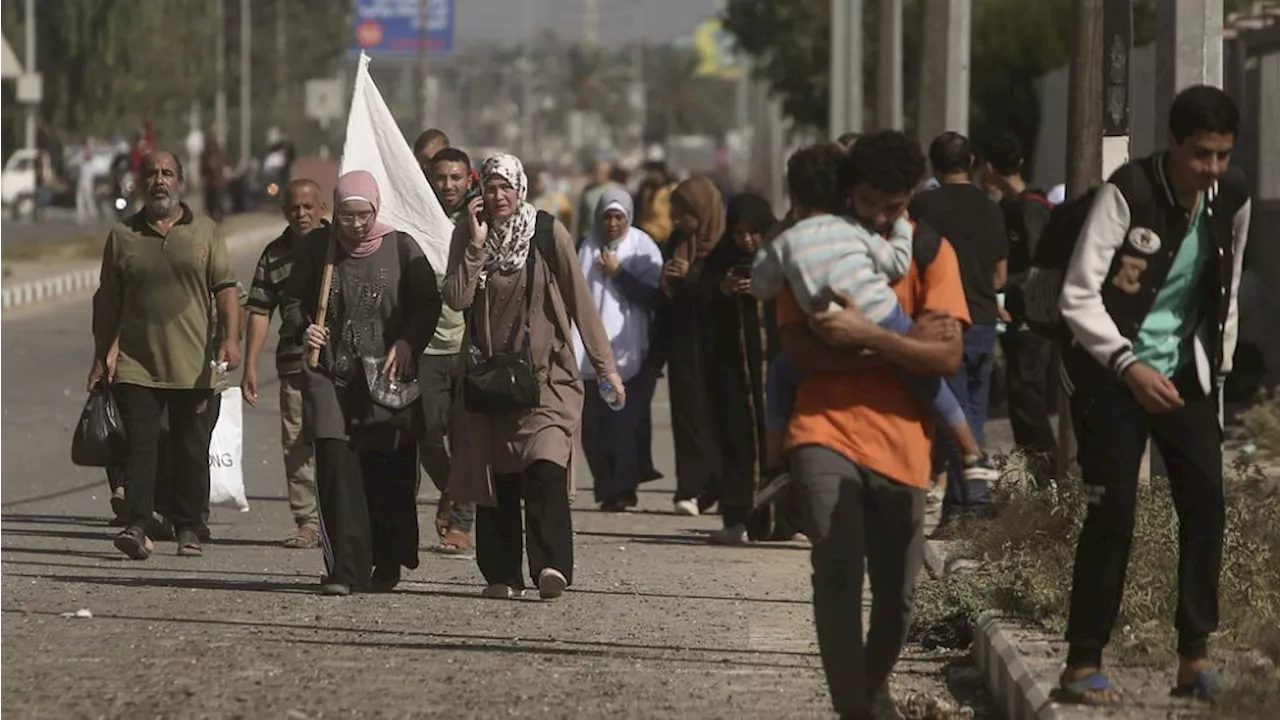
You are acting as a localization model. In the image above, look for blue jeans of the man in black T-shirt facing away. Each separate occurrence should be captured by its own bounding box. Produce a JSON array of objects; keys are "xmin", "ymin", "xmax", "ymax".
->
[{"xmin": 933, "ymin": 325, "xmax": 996, "ymax": 515}]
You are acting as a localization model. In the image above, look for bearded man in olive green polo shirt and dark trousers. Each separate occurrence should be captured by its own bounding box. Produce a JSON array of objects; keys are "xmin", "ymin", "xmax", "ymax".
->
[{"xmin": 90, "ymin": 151, "xmax": 241, "ymax": 560}]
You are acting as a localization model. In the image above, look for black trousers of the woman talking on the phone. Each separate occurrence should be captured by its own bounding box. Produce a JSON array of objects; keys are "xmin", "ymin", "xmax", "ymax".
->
[{"xmin": 476, "ymin": 460, "xmax": 573, "ymax": 589}]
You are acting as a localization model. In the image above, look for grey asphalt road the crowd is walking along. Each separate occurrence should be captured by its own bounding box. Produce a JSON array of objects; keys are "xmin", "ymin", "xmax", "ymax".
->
[{"xmin": 0, "ymin": 248, "xmax": 974, "ymax": 720}]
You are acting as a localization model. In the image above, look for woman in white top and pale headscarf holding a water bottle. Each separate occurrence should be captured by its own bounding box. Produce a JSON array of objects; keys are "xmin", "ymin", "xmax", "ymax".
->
[{"xmin": 576, "ymin": 188, "xmax": 662, "ymax": 512}]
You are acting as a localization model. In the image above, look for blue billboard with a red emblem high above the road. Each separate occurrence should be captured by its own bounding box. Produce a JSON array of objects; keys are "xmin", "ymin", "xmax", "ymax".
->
[{"xmin": 351, "ymin": 0, "xmax": 453, "ymax": 55}]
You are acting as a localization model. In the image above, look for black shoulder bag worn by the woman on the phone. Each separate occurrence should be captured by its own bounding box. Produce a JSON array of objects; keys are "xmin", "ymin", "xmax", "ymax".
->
[{"xmin": 462, "ymin": 213, "xmax": 556, "ymax": 415}]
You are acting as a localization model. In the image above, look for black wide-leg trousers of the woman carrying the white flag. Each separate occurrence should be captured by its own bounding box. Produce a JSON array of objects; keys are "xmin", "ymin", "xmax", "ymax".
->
[{"xmin": 315, "ymin": 439, "xmax": 417, "ymax": 588}]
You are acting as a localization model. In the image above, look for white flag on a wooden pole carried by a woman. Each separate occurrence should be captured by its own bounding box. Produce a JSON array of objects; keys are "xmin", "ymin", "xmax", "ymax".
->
[{"xmin": 340, "ymin": 53, "xmax": 453, "ymax": 275}]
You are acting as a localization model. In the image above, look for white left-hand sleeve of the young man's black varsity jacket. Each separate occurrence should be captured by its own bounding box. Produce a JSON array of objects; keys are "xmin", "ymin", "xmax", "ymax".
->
[{"xmin": 1059, "ymin": 183, "xmax": 1138, "ymax": 375}]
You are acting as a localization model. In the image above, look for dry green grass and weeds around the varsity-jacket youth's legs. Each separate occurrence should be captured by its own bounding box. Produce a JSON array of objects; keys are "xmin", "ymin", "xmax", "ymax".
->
[{"xmin": 913, "ymin": 453, "xmax": 1280, "ymax": 665}]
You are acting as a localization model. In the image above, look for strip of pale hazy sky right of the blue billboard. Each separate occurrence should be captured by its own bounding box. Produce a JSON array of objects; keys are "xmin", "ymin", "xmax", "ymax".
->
[{"xmin": 454, "ymin": 0, "xmax": 723, "ymax": 45}]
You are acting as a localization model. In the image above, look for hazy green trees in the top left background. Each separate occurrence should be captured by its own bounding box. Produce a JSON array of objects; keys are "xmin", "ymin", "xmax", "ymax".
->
[{"xmin": 0, "ymin": 0, "xmax": 349, "ymax": 156}]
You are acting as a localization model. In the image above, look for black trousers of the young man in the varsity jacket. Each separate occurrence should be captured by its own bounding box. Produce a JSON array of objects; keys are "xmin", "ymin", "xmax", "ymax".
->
[{"xmin": 1066, "ymin": 373, "xmax": 1225, "ymax": 666}]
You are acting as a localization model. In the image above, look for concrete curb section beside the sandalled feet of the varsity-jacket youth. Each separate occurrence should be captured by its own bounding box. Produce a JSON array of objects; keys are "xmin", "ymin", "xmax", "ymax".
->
[{"xmin": 973, "ymin": 611, "xmax": 1061, "ymax": 720}]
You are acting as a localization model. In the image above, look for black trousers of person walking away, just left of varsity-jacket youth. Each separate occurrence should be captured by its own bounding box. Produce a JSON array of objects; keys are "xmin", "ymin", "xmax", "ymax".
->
[{"xmin": 1000, "ymin": 331, "xmax": 1057, "ymax": 469}]
